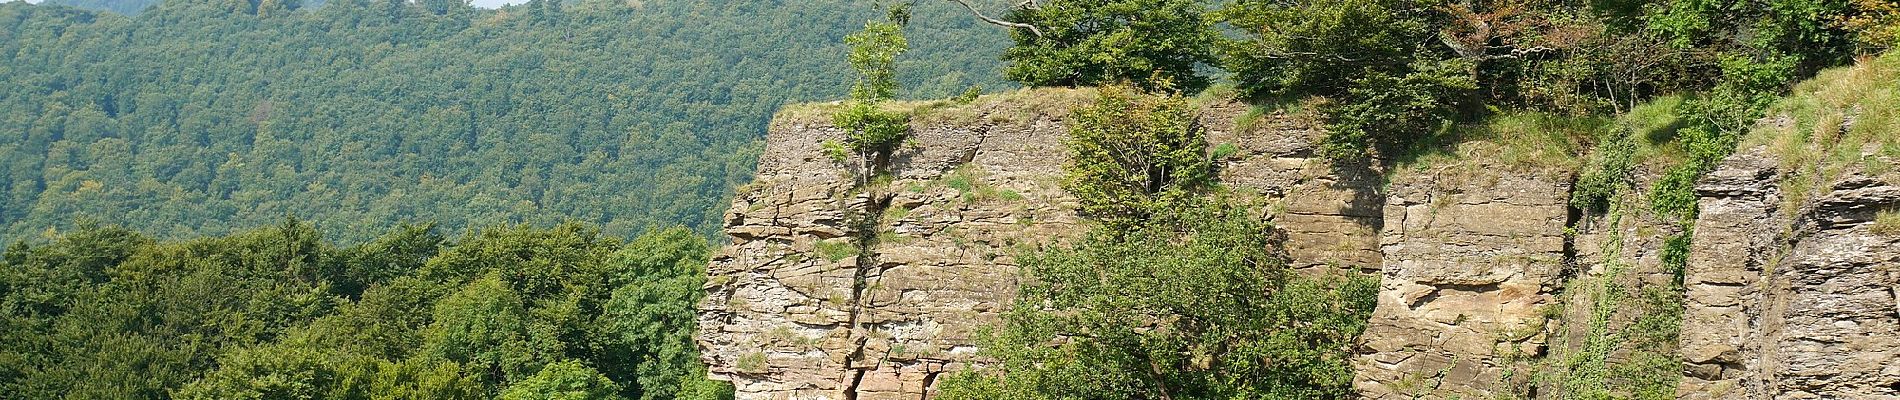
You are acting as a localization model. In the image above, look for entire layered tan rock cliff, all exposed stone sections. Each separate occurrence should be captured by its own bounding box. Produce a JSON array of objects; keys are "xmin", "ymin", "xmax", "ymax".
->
[{"xmin": 699, "ymin": 89, "xmax": 1900, "ymax": 400}]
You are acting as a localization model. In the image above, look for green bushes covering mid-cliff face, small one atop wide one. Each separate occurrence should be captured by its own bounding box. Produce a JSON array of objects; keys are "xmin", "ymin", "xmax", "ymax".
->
[{"xmin": 942, "ymin": 87, "xmax": 1378, "ymax": 400}]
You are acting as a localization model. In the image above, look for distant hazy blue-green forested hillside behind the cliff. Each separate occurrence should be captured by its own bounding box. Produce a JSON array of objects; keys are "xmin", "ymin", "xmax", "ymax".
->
[{"xmin": 0, "ymin": 0, "xmax": 1009, "ymax": 241}]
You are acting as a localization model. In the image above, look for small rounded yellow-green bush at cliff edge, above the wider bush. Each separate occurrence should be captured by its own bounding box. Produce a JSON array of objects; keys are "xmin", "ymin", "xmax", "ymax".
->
[{"xmin": 1062, "ymin": 85, "xmax": 1214, "ymax": 229}]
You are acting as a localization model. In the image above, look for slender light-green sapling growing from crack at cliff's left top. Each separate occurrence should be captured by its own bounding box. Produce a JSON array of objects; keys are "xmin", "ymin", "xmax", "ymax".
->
[{"xmin": 828, "ymin": 4, "xmax": 910, "ymax": 180}]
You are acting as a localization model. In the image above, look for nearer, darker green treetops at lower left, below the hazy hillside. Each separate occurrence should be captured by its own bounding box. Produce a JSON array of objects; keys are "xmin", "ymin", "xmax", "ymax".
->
[{"xmin": 0, "ymin": 220, "xmax": 732, "ymax": 400}]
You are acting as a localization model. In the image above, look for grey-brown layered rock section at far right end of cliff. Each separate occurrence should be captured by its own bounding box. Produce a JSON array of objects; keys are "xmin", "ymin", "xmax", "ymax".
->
[{"xmin": 1678, "ymin": 148, "xmax": 1900, "ymax": 400}]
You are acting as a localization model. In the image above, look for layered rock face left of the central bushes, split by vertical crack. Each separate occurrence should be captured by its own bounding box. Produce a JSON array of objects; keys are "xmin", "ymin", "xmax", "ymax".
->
[{"xmin": 699, "ymin": 92, "xmax": 1079, "ymax": 400}]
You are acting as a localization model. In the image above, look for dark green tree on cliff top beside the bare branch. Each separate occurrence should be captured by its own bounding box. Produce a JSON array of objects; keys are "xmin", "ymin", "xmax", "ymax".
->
[{"xmin": 1003, "ymin": 0, "xmax": 1220, "ymax": 93}]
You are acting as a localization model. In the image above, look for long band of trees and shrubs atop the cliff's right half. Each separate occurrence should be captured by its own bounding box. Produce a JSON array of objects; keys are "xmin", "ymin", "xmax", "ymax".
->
[{"xmin": 1216, "ymin": 0, "xmax": 1854, "ymax": 163}]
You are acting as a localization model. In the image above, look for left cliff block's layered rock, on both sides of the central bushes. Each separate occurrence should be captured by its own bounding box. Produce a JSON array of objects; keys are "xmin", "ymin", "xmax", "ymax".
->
[{"xmin": 699, "ymin": 89, "xmax": 1383, "ymax": 400}]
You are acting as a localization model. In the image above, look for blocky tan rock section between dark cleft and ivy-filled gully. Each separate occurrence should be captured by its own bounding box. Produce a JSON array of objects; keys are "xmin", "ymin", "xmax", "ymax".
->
[{"xmin": 1355, "ymin": 167, "xmax": 1571, "ymax": 398}]
